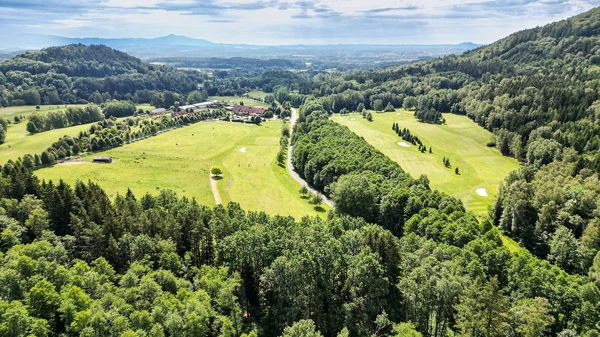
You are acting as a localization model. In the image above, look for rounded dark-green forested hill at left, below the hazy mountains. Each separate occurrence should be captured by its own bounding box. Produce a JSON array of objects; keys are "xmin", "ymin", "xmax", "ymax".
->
[{"xmin": 0, "ymin": 44, "xmax": 200, "ymax": 106}]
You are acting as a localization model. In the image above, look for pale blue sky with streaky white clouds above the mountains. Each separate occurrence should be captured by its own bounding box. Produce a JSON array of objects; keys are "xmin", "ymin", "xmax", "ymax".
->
[{"xmin": 0, "ymin": 0, "xmax": 600, "ymax": 45}]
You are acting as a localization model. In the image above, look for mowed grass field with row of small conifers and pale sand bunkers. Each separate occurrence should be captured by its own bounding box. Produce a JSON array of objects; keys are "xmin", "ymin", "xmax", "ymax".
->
[{"xmin": 333, "ymin": 109, "xmax": 519, "ymax": 214}]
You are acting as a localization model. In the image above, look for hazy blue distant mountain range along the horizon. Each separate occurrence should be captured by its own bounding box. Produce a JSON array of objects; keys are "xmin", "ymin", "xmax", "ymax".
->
[{"xmin": 0, "ymin": 34, "xmax": 481, "ymax": 61}]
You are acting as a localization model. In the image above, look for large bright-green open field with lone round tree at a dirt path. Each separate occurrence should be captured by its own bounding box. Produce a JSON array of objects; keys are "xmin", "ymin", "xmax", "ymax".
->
[{"xmin": 36, "ymin": 121, "xmax": 328, "ymax": 217}]
